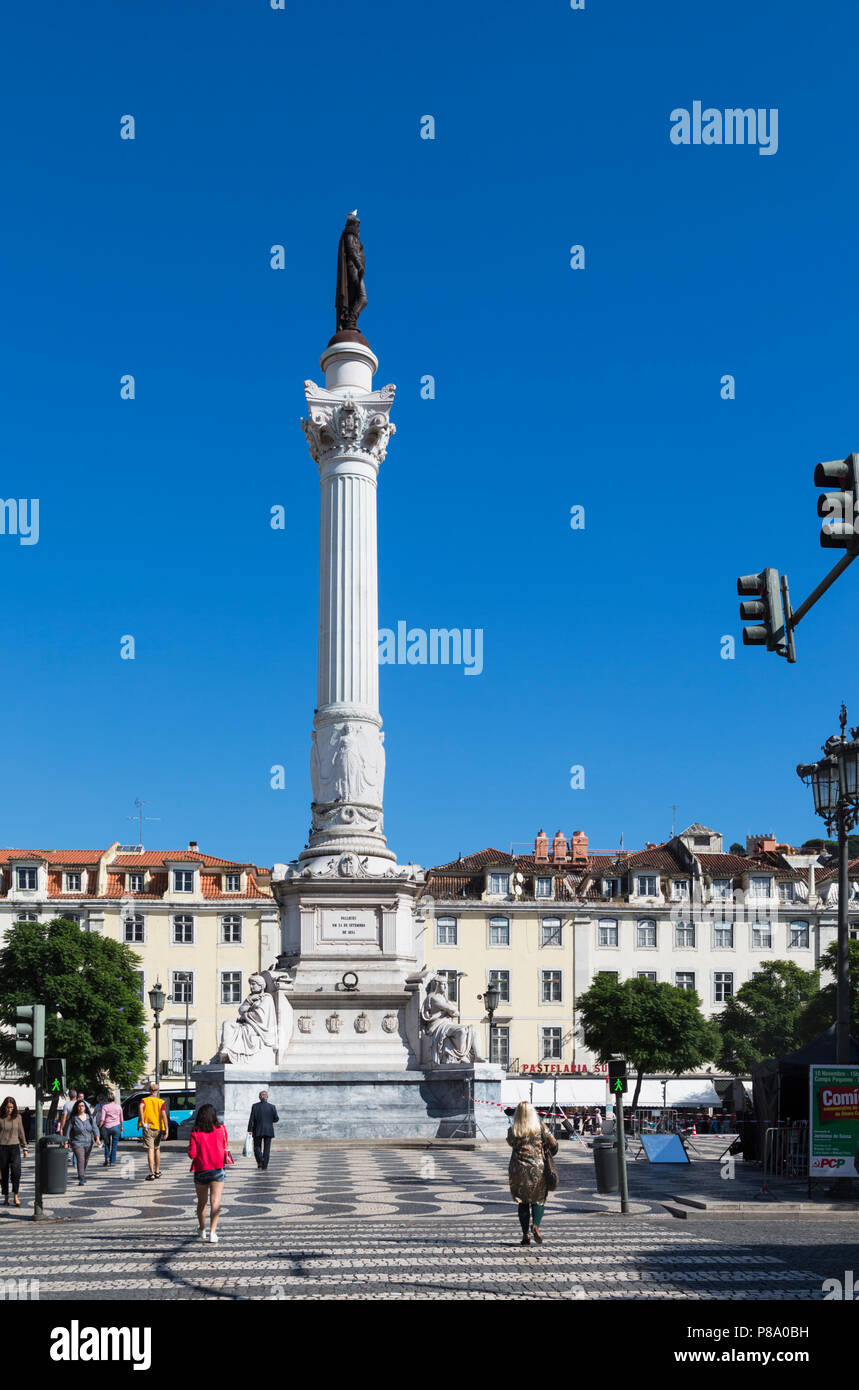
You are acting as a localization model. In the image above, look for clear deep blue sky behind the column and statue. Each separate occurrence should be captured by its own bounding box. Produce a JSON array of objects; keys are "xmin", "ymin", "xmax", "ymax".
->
[{"xmin": 0, "ymin": 0, "xmax": 859, "ymax": 865}]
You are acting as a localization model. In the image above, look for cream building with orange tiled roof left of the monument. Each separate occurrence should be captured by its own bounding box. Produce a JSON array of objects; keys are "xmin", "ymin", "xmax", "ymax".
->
[{"xmin": 0, "ymin": 841, "xmax": 273, "ymax": 1076}]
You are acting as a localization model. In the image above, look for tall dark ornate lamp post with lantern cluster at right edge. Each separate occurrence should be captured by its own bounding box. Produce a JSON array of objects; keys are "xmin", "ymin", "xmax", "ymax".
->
[{"xmin": 796, "ymin": 705, "xmax": 859, "ymax": 1065}]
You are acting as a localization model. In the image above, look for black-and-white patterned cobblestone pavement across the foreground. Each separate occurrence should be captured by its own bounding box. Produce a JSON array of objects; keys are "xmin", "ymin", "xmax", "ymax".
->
[{"xmin": 0, "ymin": 1148, "xmax": 849, "ymax": 1301}]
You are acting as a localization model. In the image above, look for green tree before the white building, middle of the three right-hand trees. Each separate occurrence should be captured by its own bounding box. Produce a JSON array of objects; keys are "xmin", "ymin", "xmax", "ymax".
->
[{"xmin": 719, "ymin": 960, "xmax": 819, "ymax": 1073}]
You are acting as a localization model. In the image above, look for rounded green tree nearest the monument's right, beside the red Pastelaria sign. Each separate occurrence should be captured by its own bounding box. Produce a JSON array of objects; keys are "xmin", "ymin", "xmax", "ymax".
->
[{"xmin": 575, "ymin": 974, "xmax": 720, "ymax": 1109}]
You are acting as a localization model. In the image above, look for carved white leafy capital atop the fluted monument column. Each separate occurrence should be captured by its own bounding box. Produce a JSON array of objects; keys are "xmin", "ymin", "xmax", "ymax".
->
[{"xmin": 302, "ymin": 381, "xmax": 396, "ymax": 467}]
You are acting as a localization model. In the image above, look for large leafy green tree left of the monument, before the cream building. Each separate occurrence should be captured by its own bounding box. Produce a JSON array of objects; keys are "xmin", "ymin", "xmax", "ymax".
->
[{"xmin": 0, "ymin": 917, "xmax": 146, "ymax": 1095}]
